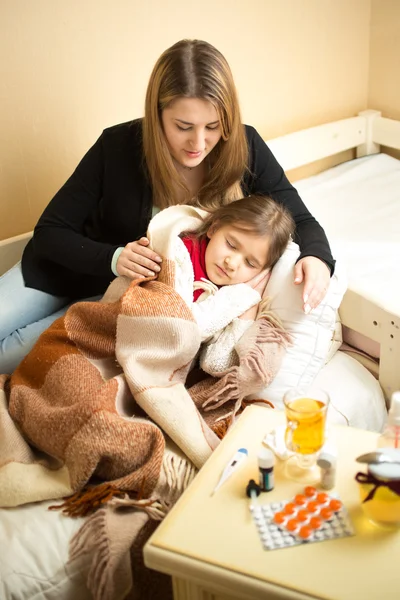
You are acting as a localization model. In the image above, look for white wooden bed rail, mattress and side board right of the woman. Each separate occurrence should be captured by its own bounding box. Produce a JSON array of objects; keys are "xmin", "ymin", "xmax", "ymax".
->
[{"xmin": 268, "ymin": 110, "xmax": 400, "ymax": 401}]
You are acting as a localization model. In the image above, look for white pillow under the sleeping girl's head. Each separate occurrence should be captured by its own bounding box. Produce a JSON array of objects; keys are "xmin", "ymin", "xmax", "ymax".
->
[{"xmin": 250, "ymin": 242, "xmax": 347, "ymax": 408}]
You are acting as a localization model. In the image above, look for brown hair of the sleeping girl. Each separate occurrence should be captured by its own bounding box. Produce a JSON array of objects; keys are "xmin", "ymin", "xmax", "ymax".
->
[{"xmin": 196, "ymin": 195, "xmax": 294, "ymax": 268}]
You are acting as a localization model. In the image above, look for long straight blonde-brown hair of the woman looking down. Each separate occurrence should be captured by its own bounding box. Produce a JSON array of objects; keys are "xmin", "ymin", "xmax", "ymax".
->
[{"xmin": 143, "ymin": 40, "xmax": 248, "ymax": 210}]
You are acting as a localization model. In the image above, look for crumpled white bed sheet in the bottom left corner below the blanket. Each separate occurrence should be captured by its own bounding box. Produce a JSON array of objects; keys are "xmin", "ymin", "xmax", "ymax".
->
[{"xmin": 0, "ymin": 500, "xmax": 92, "ymax": 600}]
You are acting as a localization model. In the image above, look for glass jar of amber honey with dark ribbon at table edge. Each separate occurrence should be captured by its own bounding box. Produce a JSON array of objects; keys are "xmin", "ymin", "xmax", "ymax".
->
[{"xmin": 356, "ymin": 449, "xmax": 400, "ymax": 529}]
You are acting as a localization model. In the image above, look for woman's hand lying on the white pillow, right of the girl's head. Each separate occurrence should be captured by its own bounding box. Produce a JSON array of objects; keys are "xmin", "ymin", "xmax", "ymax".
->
[{"xmin": 294, "ymin": 256, "xmax": 331, "ymax": 315}]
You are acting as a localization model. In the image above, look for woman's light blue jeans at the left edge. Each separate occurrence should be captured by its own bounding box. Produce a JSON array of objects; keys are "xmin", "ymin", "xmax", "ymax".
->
[{"xmin": 0, "ymin": 263, "xmax": 101, "ymax": 374}]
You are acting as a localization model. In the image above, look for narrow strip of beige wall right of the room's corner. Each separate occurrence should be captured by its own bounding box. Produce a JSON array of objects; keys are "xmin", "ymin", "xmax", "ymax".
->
[{"xmin": 368, "ymin": 0, "xmax": 400, "ymax": 158}]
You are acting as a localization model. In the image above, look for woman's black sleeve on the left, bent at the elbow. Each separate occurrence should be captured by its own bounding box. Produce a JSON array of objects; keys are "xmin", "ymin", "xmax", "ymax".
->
[{"xmin": 32, "ymin": 134, "xmax": 117, "ymax": 277}]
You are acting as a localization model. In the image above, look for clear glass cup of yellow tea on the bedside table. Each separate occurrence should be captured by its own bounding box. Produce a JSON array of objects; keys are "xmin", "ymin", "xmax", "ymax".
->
[{"xmin": 283, "ymin": 388, "xmax": 329, "ymax": 483}]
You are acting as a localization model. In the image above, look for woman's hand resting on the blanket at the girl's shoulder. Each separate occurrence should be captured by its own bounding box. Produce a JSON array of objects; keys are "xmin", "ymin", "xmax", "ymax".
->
[{"xmin": 116, "ymin": 237, "xmax": 162, "ymax": 279}]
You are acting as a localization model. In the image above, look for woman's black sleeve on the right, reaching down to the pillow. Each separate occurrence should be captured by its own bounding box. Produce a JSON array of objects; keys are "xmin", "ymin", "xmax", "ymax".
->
[{"xmin": 245, "ymin": 125, "xmax": 335, "ymax": 275}]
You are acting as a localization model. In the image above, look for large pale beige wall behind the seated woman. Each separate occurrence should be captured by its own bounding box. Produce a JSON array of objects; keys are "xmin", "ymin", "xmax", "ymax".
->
[{"xmin": 0, "ymin": 0, "xmax": 372, "ymax": 239}]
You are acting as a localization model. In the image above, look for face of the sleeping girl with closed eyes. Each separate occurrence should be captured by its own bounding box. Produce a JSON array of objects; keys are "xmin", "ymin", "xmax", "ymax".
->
[{"xmin": 205, "ymin": 225, "xmax": 269, "ymax": 286}]
